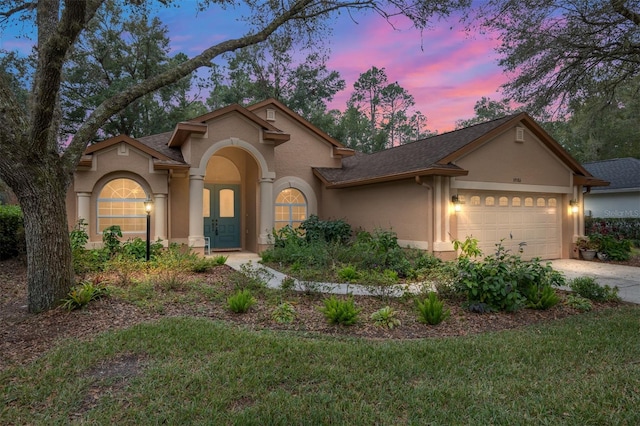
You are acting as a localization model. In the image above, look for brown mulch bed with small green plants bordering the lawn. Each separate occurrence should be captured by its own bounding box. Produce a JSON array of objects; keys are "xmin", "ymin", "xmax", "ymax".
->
[{"xmin": 0, "ymin": 255, "xmax": 640, "ymax": 371}]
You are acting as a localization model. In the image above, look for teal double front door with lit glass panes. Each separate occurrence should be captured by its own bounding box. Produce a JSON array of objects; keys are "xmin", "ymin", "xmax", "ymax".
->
[{"xmin": 203, "ymin": 184, "xmax": 241, "ymax": 249}]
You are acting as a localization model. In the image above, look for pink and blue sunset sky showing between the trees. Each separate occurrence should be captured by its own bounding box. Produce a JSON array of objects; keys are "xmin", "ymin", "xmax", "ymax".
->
[{"xmin": 0, "ymin": 1, "xmax": 506, "ymax": 133}]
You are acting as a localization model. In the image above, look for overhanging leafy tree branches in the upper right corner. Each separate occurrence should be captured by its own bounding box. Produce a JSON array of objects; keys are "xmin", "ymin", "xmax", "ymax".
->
[{"xmin": 472, "ymin": 0, "xmax": 640, "ymax": 116}]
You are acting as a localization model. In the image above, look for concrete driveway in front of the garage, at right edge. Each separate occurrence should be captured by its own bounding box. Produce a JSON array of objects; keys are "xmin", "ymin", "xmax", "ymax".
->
[{"xmin": 551, "ymin": 259, "xmax": 640, "ymax": 304}]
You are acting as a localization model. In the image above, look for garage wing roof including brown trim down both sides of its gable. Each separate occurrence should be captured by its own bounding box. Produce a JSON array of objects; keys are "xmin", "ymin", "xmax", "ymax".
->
[{"xmin": 314, "ymin": 113, "xmax": 606, "ymax": 188}]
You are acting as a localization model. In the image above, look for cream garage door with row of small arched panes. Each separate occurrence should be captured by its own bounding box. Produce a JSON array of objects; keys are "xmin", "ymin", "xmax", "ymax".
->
[{"xmin": 456, "ymin": 191, "xmax": 562, "ymax": 259}]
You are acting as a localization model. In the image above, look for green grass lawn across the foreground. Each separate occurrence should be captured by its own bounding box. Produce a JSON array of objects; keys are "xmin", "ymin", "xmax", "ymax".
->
[{"xmin": 0, "ymin": 307, "xmax": 640, "ymax": 425}]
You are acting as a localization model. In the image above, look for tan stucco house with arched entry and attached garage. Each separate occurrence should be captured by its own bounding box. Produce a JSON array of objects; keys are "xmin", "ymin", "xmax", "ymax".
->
[{"xmin": 67, "ymin": 99, "xmax": 606, "ymax": 259}]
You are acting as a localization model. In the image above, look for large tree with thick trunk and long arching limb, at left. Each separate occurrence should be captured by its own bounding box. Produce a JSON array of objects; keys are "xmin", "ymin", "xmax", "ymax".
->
[{"xmin": 0, "ymin": 0, "xmax": 468, "ymax": 312}]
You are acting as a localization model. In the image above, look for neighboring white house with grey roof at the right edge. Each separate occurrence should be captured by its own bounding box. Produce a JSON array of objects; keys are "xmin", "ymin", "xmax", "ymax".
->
[{"xmin": 583, "ymin": 157, "xmax": 640, "ymax": 218}]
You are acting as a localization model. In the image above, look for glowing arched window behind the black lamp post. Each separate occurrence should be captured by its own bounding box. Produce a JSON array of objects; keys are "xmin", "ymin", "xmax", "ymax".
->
[{"xmin": 97, "ymin": 178, "xmax": 147, "ymax": 233}]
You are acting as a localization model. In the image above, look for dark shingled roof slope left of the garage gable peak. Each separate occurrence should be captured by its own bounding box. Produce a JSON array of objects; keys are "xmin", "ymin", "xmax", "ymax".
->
[{"xmin": 314, "ymin": 114, "xmax": 517, "ymax": 186}]
